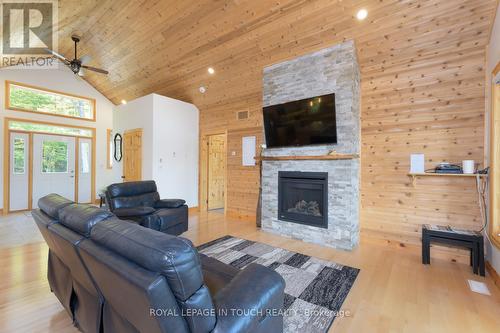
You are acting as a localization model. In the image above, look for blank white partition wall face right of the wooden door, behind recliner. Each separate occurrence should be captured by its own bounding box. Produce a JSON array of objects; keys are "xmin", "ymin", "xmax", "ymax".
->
[{"xmin": 153, "ymin": 94, "xmax": 199, "ymax": 207}]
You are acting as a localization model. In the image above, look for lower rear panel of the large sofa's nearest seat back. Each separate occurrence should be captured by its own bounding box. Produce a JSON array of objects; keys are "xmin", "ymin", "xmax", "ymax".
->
[{"xmin": 79, "ymin": 237, "xmax": 189, "ymax": 333}]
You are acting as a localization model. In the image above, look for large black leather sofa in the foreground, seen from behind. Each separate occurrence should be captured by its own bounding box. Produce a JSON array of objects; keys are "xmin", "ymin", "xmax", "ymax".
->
[{"xmin": 33, "ymin": 194, "xmax": 285, "ymax": 333}]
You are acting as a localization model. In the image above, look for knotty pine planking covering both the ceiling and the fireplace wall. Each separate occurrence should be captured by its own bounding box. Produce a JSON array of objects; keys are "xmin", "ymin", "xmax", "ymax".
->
[{"xmin": 59, "ymin": 0, "xmax": 497, "ymax": 244}]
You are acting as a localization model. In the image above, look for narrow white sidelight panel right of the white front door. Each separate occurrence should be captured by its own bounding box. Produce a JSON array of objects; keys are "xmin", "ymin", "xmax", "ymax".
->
[{"xmin": 78, "ymin": 138, "xmax": 92, "ymax": 203}]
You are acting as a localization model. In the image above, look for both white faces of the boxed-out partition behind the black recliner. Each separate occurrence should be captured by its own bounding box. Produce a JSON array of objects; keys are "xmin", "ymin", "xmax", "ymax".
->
[{"xmin": 113, "ymin": 94, "xmax": 199, "ymax": 207}]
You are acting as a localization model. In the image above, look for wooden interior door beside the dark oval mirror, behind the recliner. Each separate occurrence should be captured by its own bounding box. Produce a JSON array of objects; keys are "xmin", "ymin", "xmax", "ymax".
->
[{"xmin": 122, "ymin": 129, "xmax": 142, "ymax": 182}]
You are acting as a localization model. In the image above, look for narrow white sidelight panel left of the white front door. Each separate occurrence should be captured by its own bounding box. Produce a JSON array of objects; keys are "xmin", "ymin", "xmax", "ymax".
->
[{"xmin": 9, "ymin": 133, "xmax": 30, "ymax": 212}]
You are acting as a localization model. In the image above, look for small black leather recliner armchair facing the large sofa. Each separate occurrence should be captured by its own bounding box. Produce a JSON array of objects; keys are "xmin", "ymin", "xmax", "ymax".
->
[{"xmin": 106, "ymin": 180, "xmax": 188, "ymax": 235}]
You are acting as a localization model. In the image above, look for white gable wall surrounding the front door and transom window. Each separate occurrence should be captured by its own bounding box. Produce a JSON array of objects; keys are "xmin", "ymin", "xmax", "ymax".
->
[{"xmin": 0, "ymin": 65, "xmax": 114, "ymax": 206}]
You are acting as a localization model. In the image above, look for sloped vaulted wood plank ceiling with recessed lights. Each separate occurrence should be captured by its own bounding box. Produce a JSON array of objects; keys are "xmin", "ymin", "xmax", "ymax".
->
[{"xmin": 59, "ymin": 0, "xmax": 496, "ymax": 106}]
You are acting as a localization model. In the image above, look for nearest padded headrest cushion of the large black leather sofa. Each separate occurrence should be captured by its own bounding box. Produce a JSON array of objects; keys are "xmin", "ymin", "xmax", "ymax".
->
[{"xmin": 90, "ymin": 219, "xmax": 216, "ymax": 332}]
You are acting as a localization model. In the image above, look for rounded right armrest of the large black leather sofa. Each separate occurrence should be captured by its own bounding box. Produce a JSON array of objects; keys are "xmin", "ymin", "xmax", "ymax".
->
[{"xmin": 213, "ymin": 264, "xmax": 285, "ymax": 333}]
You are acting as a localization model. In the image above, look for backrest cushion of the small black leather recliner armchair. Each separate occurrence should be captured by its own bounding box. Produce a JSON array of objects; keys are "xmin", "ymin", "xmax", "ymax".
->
[{"xmin": 106, "ymin": 180, "xmax": 160, "ymax": 210}]
